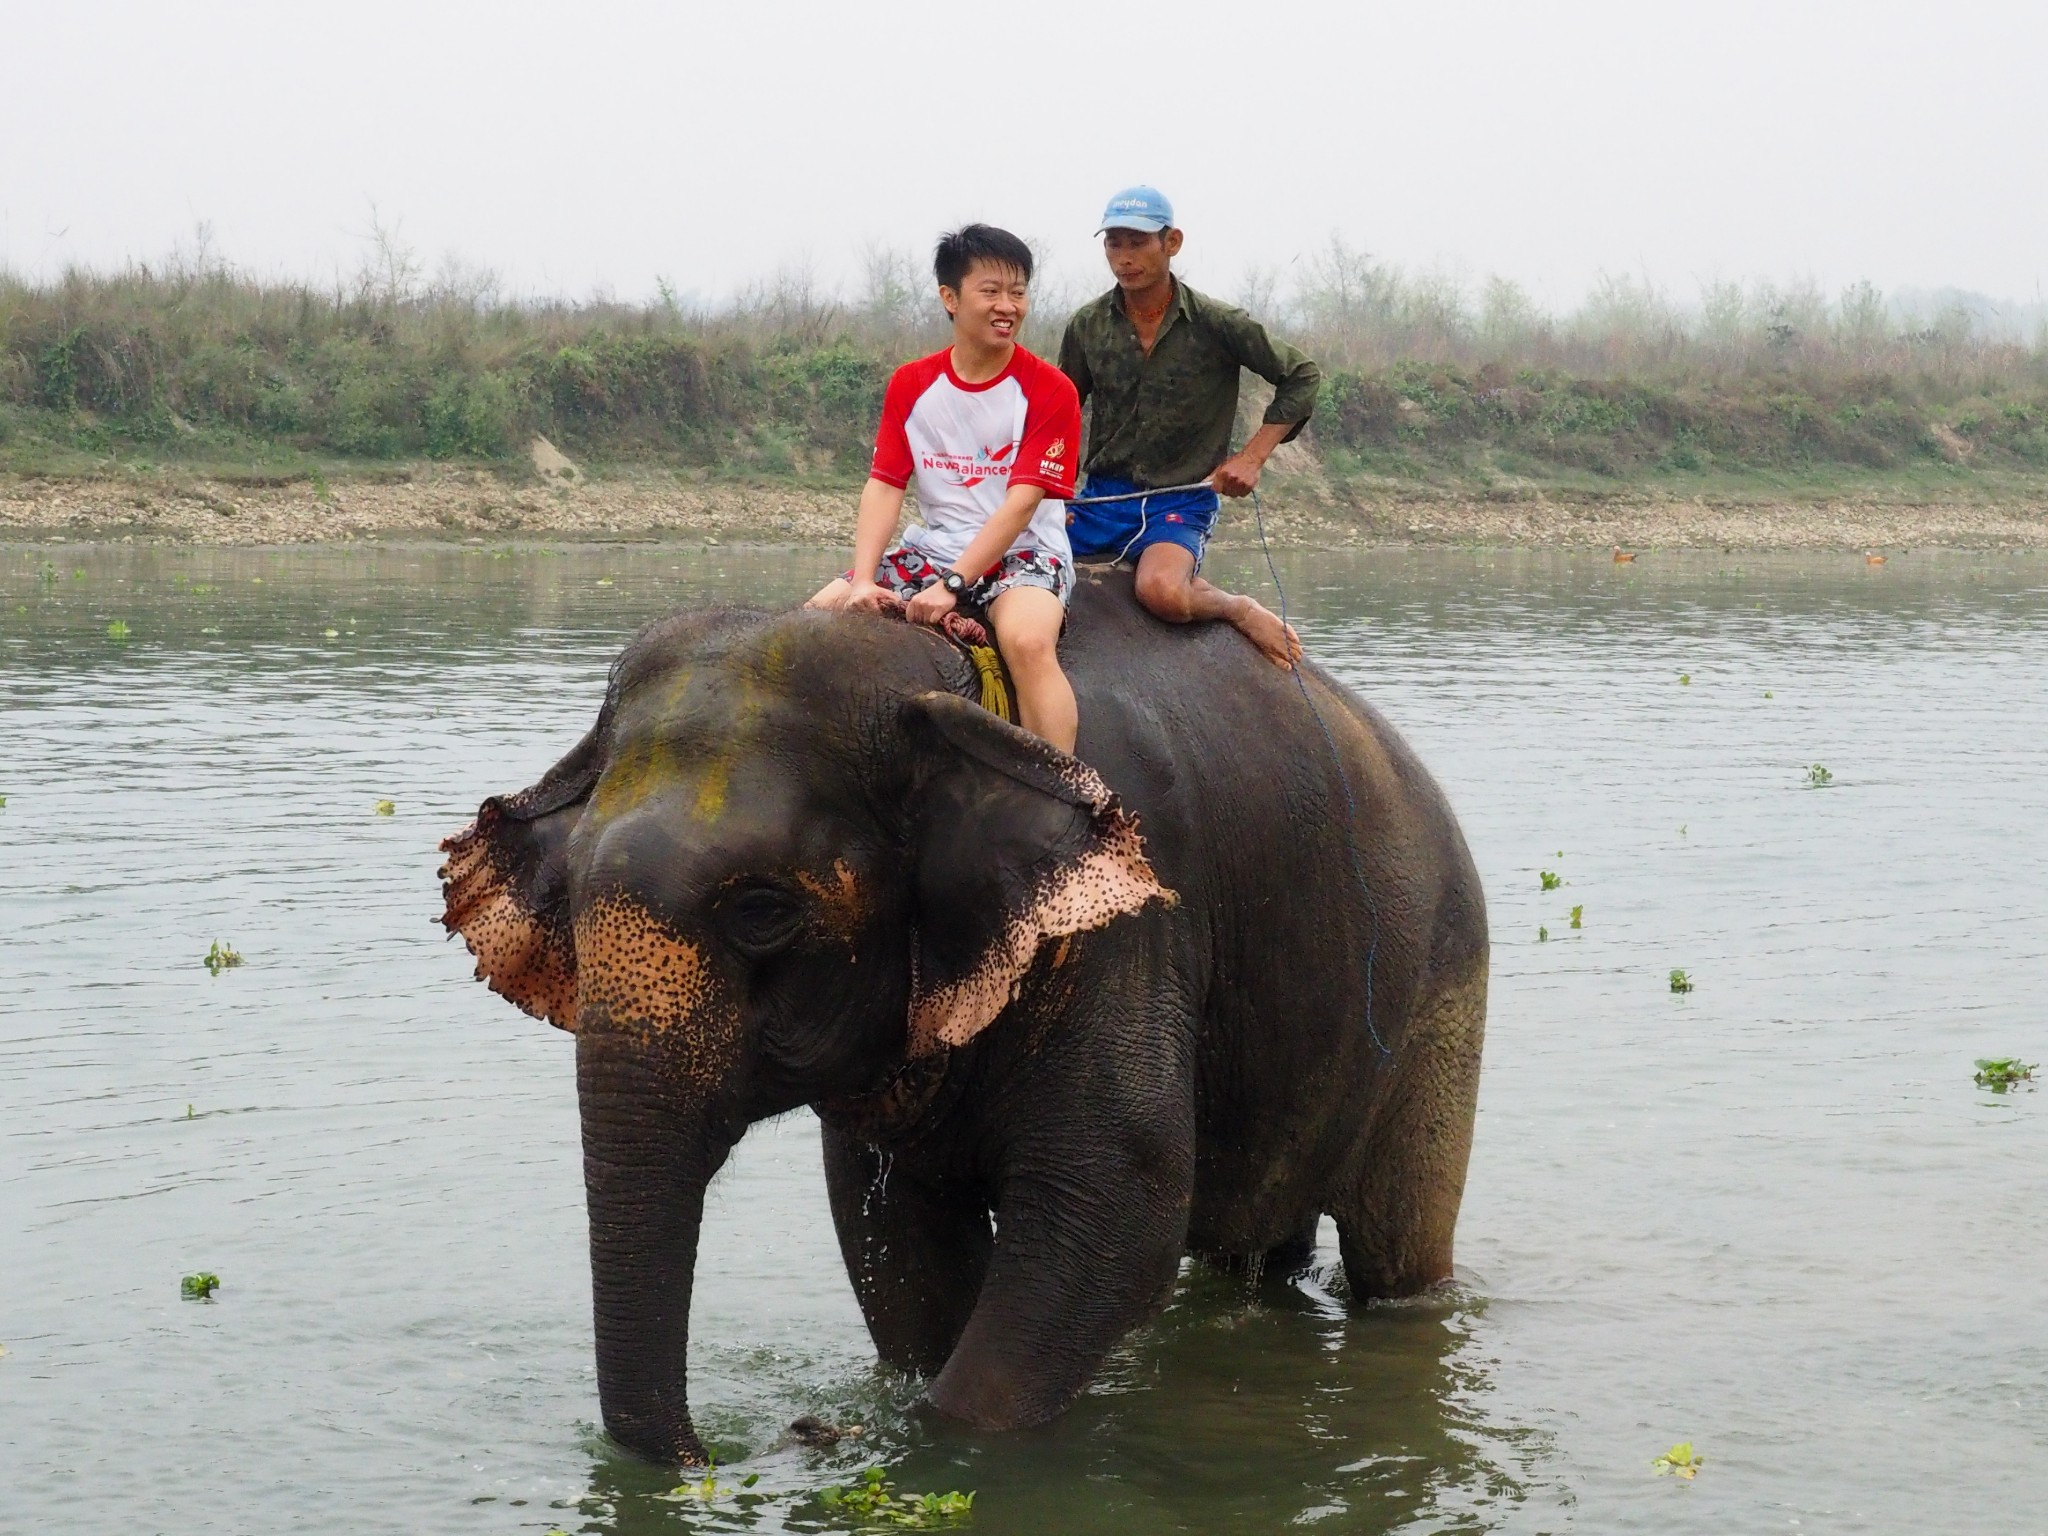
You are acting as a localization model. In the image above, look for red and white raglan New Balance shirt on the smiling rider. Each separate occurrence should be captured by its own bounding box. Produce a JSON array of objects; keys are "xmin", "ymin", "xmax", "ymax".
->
[{"xmin": 868, "ymin": 346, "xmax": 1081, "ymax": 565}]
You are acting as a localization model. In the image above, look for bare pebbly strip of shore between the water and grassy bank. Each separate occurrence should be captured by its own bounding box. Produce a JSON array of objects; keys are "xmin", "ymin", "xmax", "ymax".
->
[{"xmin": 0, "ymin": 465, "xmax": 2048, "ymax": 551}]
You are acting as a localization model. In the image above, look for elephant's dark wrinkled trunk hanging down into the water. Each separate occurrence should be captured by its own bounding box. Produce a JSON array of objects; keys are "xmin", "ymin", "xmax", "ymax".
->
[{"xmin": 575, "ymin": 1034, "xmax": 731, "ymax": 1462}]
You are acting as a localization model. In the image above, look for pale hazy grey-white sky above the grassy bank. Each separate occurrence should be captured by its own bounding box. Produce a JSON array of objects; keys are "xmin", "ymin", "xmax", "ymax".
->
[{"xmin": 0, "ymin": 0, "xmax": 2048, "ymax": 313}]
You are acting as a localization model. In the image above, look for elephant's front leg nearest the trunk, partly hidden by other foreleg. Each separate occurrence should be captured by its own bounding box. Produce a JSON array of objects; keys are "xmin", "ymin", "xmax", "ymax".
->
[{"xmin": 825, "ymin": 1126, "xmax": 989, "ymax": 1376}]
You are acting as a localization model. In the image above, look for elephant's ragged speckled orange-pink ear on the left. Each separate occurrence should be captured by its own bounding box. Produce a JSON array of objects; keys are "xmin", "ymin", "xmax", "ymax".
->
[{"xmin": 440, "ymin": 711, "xmax": 608, "ymax": 1030}]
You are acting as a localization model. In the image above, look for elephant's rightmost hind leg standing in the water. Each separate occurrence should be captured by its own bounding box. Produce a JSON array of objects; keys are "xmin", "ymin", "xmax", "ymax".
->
[{"xmin": 1329, "ymin": 950, "xmax": 1487, "ymax": 1300}]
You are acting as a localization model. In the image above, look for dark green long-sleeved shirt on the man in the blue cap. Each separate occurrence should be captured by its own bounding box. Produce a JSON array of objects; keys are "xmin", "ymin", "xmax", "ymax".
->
[{"xmin": 1059, "ymin": 279, "xmax": 1323, "ymax": 485}]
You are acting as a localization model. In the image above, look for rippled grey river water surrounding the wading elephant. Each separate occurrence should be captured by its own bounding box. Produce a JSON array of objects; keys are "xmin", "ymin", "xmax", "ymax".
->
[{"xmin": 0, "ymin": 545, "xmax": 2048, "ymax": 1536}]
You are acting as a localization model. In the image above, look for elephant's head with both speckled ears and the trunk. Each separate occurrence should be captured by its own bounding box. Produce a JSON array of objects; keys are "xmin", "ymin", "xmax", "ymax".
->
[{"xmin": 442, "ymin": 612, "xmax": 1171, "ymax": 1460}]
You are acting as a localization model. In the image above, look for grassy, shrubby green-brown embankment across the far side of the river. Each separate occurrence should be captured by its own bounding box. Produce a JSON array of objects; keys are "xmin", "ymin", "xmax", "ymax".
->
[{"xmin": 12, "ymin": 248, "xmax": 2048, "ymax": 500}]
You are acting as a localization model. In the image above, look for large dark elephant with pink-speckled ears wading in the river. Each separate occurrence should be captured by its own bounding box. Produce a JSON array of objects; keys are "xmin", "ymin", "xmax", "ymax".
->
[{"xmin": 440, "ymin": 571, "xmax": 1489, "ymax": 1462}]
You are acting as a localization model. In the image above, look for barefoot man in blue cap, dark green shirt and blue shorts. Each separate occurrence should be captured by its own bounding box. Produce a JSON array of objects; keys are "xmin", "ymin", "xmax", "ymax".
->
[{"xmin": 1059, "ymin": 186, "xmax": 1321, "ymax": 666}]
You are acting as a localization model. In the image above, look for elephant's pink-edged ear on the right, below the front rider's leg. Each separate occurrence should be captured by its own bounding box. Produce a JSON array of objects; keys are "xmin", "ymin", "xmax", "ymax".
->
[{"xmin": 903, "ymin": 692, "xmax": 1176, "ymax": 1057}]
